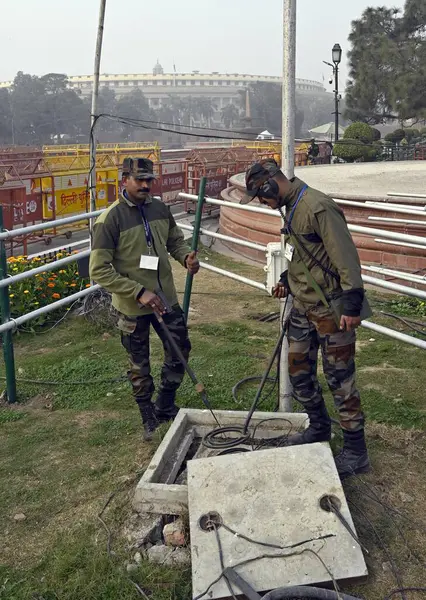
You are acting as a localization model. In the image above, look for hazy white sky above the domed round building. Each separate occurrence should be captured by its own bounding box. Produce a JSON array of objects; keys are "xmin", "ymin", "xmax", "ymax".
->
[{"xmin": 0, "ymin": 0, "xmax": 404, "ymax": 89}]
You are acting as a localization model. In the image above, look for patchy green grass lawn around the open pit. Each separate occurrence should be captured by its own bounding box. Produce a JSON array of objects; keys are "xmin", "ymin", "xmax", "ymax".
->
[{"xmin": 0, "ymin": 251, "xmax": 426, "ymax": 600}]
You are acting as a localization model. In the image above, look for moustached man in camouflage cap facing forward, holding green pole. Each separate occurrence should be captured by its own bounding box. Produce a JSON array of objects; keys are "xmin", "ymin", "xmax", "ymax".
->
[{"xmin": 90, "ymin": 158, "xmax": 199, "ymax": 440}]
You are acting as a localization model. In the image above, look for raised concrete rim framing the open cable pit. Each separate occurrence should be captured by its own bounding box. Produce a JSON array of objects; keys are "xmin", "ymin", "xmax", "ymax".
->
[{"xmin": 133, "ymin": 409, "xmax": 308, "ymax": 515}]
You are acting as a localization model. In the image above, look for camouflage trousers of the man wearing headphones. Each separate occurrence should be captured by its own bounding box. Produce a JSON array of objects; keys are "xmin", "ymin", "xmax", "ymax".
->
[{"xmin": 287, "ymin": 306, "xmax": 364, "ymax": 431}]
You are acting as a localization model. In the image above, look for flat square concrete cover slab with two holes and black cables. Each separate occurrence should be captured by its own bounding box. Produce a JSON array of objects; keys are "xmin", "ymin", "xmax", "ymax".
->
[{"xmin": 188, "ymin": 444, "xmax": 367, "ymax": 598}]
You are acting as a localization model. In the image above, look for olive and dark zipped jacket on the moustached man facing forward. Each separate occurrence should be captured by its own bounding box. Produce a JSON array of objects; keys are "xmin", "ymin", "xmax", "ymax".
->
[{"xmin": 90, "ymin": 194, "xmax": 191, "ymax": 317}]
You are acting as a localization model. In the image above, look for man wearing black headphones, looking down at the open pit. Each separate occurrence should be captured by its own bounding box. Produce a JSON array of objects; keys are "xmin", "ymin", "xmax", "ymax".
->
[{"xmin": 242, "ymin": 160, "xmax": 371, "ymax": 478}]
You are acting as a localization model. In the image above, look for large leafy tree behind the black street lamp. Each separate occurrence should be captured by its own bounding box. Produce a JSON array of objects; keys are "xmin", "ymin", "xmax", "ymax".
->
[{"xmin": 346, "ymin": 0, "xmax": 426, "ymax": 124}]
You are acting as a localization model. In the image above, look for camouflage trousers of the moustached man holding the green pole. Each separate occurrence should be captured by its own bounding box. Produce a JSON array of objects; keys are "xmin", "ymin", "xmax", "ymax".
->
[{"xmin": 118, "ymin": 305, "xmax": 191, "ymax": 409}]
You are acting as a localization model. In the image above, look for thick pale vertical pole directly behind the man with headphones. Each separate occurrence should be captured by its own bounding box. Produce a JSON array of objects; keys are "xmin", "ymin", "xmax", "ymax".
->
[{"xmin": 279, "ymin": 0, "xmax": 297, "ymax": 412}]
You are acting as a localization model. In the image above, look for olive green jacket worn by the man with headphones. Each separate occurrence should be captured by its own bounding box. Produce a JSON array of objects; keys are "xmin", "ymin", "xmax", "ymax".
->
[{"xmin": 283, "ymin": 177, "xmax": 364, "ymax": 316}]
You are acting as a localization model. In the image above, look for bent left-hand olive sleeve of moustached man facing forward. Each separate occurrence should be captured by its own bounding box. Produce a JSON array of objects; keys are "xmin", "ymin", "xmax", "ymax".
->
[{"xmin": 90, "ymin": 219, "xmax": 144, "ymax": 300}]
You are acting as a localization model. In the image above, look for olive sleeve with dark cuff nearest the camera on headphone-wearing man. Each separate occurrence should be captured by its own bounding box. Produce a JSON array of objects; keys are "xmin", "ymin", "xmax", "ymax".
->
[{"xmin": 313, "ymin": 200, "xmax": 364, "ymax": 316}]
